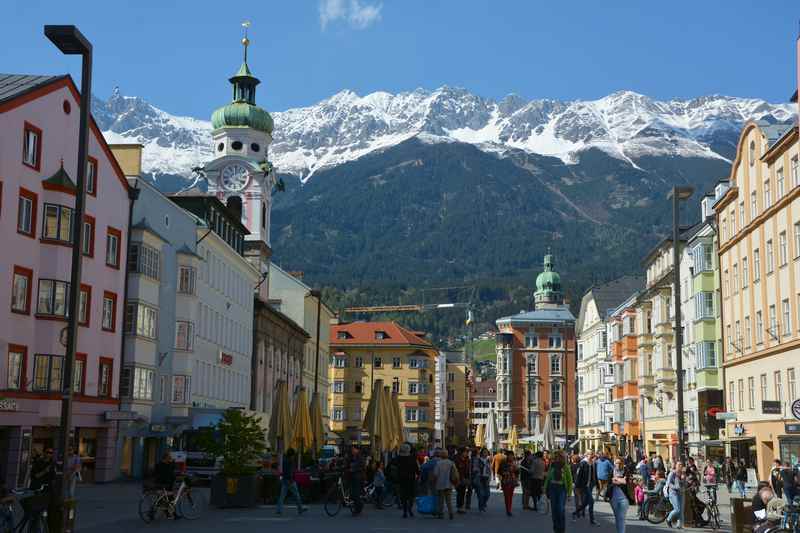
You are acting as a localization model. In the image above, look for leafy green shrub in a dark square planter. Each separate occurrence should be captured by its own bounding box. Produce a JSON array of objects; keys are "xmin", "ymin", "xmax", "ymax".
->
[{"xmin": 200, "ymin": 409, "xmax": 266, "ymax": 507}]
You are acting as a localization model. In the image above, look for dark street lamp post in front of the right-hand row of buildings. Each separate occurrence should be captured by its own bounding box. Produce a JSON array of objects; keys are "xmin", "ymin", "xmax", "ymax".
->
[{"xmin": 668, "ymin": 186, "xmax": 694, "ymax": 461}]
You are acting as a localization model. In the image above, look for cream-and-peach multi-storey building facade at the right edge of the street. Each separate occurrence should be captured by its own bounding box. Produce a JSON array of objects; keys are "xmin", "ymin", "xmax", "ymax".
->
[{"xmin": 714, "ymin": 121, "xmax": 800, "ymax": 479}]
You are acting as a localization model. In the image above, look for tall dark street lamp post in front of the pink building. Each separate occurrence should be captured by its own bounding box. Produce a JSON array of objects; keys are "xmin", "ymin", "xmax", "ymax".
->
[{"xmin": 44, "ymin": 25, "xmax": 92, "ymax": 528}]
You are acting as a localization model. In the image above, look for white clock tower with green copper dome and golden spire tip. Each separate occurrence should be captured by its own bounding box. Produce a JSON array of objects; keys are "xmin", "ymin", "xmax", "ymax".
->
[{"xmin": 203, "ymin": 23, "xmax": 275, "ymax": 299}]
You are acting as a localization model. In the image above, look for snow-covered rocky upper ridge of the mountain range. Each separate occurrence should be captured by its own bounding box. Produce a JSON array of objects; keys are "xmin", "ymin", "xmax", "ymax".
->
[{"xmin": 94, "ymin": 87, "xmax": 795, "ymax": 179}]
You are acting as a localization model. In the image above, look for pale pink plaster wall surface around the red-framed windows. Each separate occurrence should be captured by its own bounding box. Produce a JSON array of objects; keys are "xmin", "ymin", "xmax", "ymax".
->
[{"xmin": 0, "ymin": 83, "xmax": 129, "ymax": 412}]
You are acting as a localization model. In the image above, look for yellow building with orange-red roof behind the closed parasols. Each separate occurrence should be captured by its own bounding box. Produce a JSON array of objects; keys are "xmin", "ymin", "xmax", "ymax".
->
[{"xmin": 328, "ymin": 322, "xmax": 438, "ymax": 444}]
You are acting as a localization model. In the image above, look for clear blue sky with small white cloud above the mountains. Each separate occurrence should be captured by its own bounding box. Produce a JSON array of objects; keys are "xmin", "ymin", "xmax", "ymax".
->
[{"xmin": 0, "ymin": 0, "xmax": 800, "ymax": 118}]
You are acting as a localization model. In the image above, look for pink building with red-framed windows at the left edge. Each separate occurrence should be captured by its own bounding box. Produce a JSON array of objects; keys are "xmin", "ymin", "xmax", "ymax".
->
[{"xmin": 0, "ymin": 75, "xmax": 130, "ymax": 487}]
